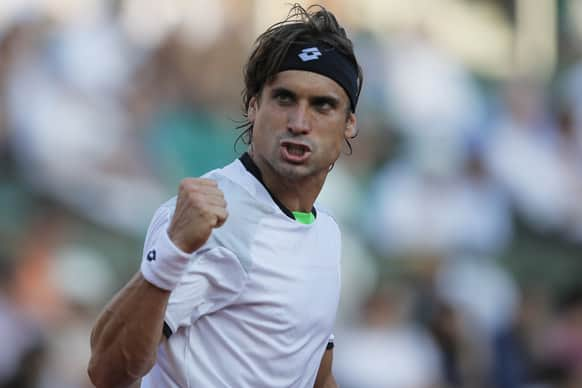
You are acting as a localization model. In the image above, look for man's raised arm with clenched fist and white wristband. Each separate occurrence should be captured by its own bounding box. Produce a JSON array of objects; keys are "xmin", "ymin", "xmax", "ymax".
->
[{"xmin": 88, "ymin": 178, "xmax": 227, "ymax": 388}]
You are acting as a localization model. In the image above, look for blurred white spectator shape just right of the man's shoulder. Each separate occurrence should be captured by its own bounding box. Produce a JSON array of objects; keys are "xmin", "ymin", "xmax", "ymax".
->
[{"xmin": 367, "ymin": 150, "xmax": 511, "ymax": 257}]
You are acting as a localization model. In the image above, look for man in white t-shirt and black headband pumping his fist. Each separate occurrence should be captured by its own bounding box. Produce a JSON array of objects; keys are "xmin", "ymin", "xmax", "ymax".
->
[{"xmin": 89, "ymin": 5, "xmax": 362, "ymax": 388}]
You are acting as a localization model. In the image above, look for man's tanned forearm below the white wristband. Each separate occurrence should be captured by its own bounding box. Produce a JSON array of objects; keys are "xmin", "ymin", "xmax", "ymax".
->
[{"xmin": 88, "ymin": 273, "xmax": 170, "ymax": 388}]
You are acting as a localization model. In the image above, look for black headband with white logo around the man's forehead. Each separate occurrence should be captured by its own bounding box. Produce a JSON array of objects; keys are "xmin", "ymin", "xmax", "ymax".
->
[{"xmin": 279, "ymin": 43, "xmax": 358, "ymax": 112}]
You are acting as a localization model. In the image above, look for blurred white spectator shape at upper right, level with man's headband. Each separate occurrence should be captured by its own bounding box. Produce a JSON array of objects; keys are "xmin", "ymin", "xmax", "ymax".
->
[{"xmin": 385, "ymin": 31, "xmax": 484, "ymax": 179}]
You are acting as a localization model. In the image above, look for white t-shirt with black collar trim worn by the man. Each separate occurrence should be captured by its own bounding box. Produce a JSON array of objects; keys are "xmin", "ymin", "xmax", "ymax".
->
[{"xmin": 142, "ymin": 160, "xmax": 341, "ymax": 388}]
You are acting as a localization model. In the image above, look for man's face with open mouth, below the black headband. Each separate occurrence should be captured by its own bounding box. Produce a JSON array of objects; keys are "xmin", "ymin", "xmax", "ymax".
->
[{"xmin": 248, "ymin": 70, "xmax": 356, "ymax": 180}]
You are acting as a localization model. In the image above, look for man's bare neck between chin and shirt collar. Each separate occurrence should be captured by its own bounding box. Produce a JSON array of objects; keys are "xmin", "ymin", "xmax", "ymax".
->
[{"xmin": 250, "ymin": 154, "xmax": 328, "ymax": 213}]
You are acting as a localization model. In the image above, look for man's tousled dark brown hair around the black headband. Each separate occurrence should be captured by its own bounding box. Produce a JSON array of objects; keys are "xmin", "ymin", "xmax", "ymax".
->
[{"xmin": 238, "ymin": 3, "xmax": 363, "ymax": 149}]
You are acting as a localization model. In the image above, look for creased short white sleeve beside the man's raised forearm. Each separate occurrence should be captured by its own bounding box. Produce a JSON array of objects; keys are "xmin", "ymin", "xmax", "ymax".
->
[{"xmin": 164, "ymin": 247, "xmax": 247, "ymax": 332}]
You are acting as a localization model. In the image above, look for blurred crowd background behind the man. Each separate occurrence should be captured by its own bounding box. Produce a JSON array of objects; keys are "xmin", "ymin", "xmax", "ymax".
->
[{"xmin": 0, "ymin": 0, "xmax": 582, "ymax": 388}]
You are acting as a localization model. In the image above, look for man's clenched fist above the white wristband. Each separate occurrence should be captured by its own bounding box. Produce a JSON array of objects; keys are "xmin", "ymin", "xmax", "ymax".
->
[{"xmin": 168, "ymin": 178, "xmax": 228, "ymax": 253}]
